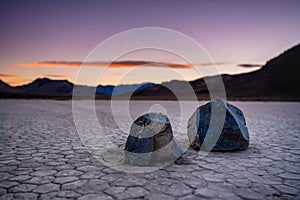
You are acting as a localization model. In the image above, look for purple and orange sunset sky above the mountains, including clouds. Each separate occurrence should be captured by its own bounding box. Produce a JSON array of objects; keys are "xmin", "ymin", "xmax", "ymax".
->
[{"xmin": 0, "ymin": 0, "xmax": 300, "ymax": 86}]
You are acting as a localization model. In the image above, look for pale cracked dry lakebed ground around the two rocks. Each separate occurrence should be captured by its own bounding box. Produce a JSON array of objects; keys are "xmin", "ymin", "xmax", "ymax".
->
[{"xmin": 0, "ymin": 100, "xmax": 300, "ymax": 199}]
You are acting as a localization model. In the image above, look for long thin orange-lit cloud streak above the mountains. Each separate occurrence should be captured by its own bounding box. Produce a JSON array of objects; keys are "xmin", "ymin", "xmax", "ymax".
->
[{"xmin": 21, "ymin": 61, "xmax": 225, "ymax": 69}]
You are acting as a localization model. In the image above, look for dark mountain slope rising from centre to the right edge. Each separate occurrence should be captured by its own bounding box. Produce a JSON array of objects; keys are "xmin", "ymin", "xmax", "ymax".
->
[{"xmin": 132, "ymin": 44, "xmax": 300, "ymax": 101}]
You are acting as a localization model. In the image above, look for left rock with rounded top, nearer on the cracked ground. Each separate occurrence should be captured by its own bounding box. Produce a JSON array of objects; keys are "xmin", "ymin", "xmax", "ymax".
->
[{"xmin": 125, "ymin": 113, "xmax": 182, "ymax": 166}]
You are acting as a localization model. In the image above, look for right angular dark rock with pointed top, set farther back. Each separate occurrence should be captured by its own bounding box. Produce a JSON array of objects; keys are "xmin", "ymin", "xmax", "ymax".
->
[{"xmin": 188, "ymin": 99, "xmax": 249, "ymax": 151}]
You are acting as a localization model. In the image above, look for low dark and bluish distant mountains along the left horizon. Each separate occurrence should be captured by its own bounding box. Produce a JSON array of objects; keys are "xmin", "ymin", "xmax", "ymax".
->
[{"xmin": 0, "ymin": 78, "xmax": 155, "ymax": 99}]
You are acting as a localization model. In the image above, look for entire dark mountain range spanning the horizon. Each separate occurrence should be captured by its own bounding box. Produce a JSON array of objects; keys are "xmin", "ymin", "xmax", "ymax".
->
[{"xmin": 0, "ymin": 44, "xmax": 300, "ymax": 101}]
